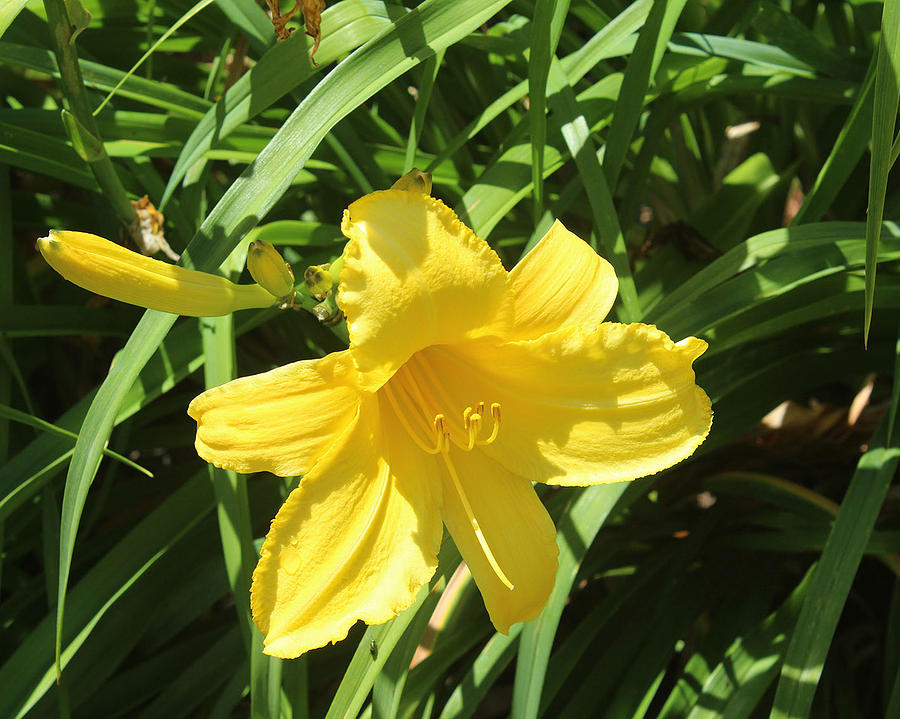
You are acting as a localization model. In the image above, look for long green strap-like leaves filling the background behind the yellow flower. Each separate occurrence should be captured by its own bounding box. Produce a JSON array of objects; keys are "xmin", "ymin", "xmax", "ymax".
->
[{"xmin": 0, "ymin": 0, "xmax": 900, "ymax": 719}]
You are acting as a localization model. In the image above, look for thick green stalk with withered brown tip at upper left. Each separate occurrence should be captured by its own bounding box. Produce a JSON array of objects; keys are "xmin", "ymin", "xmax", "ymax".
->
[{"xmin": 44, "ymin": 0, "xmax": 141, "ymax": 239}]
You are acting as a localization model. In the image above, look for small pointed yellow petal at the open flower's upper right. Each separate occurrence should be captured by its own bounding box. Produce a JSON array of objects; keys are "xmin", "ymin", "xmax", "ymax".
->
[{"xmin": 509, "ymin": 220, "xmax": 619, "ymax": 339}]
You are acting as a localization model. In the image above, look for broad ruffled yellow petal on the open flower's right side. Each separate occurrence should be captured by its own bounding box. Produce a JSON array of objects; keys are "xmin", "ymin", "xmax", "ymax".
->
[{"xmin": 420, "ymin": 323, "xmax": 712, "ymax": 485}]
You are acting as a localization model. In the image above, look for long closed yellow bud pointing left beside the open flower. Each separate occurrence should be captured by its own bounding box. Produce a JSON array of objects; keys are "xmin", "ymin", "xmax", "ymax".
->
[{"xmin": 37, "ymin": 230, "xmax": 275, "ymax": 317}]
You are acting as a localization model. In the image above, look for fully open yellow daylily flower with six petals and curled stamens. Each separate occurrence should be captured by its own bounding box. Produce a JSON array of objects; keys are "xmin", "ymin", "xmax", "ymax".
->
[{"xmin": 188, "ymin": 187, "xmax": 712, "ymax": 657}]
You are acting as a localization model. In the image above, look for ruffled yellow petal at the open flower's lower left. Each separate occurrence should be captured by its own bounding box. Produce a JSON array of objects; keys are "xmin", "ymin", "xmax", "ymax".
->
[{"xmin": 251, "ymin": 396, "xmax": 442, "ymax": 657}]
